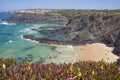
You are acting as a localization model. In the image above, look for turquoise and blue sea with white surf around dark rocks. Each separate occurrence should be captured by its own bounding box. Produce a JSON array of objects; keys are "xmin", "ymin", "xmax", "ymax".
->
[{"xmin": 0, "ymin": 12, "xmax": 75, "ymax": 63}]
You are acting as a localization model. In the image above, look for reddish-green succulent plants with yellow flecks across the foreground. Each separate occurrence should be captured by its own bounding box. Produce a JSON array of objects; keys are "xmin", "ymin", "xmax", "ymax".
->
[{"xmin": 0, "ymin": 57, "xmax": 120, "ymax": 80}]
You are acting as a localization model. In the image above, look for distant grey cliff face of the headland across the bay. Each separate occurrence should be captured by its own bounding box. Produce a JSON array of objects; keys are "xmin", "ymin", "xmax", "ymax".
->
[{"xmin": 4, "ymin": 12, "xmax": 68, "ymax": 25}]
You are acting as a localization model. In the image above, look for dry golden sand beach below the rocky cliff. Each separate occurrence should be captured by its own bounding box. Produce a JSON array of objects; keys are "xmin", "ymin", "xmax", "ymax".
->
[{"xmin": 73, "ymin": 43, "xmax": 119, "ymax": 63}]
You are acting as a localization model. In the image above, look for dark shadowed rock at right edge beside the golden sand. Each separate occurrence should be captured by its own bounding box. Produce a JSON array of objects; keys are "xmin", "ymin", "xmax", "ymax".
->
[{"xmin": 113, "ymin": 32, "xmax": 120, "ymax": 56}]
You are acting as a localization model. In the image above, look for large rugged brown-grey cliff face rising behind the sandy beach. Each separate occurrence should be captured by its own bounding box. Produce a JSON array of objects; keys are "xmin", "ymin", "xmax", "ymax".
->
[{"xmin": 67, "ymin": 12, "xmax": 120, "ymax": 46}]
